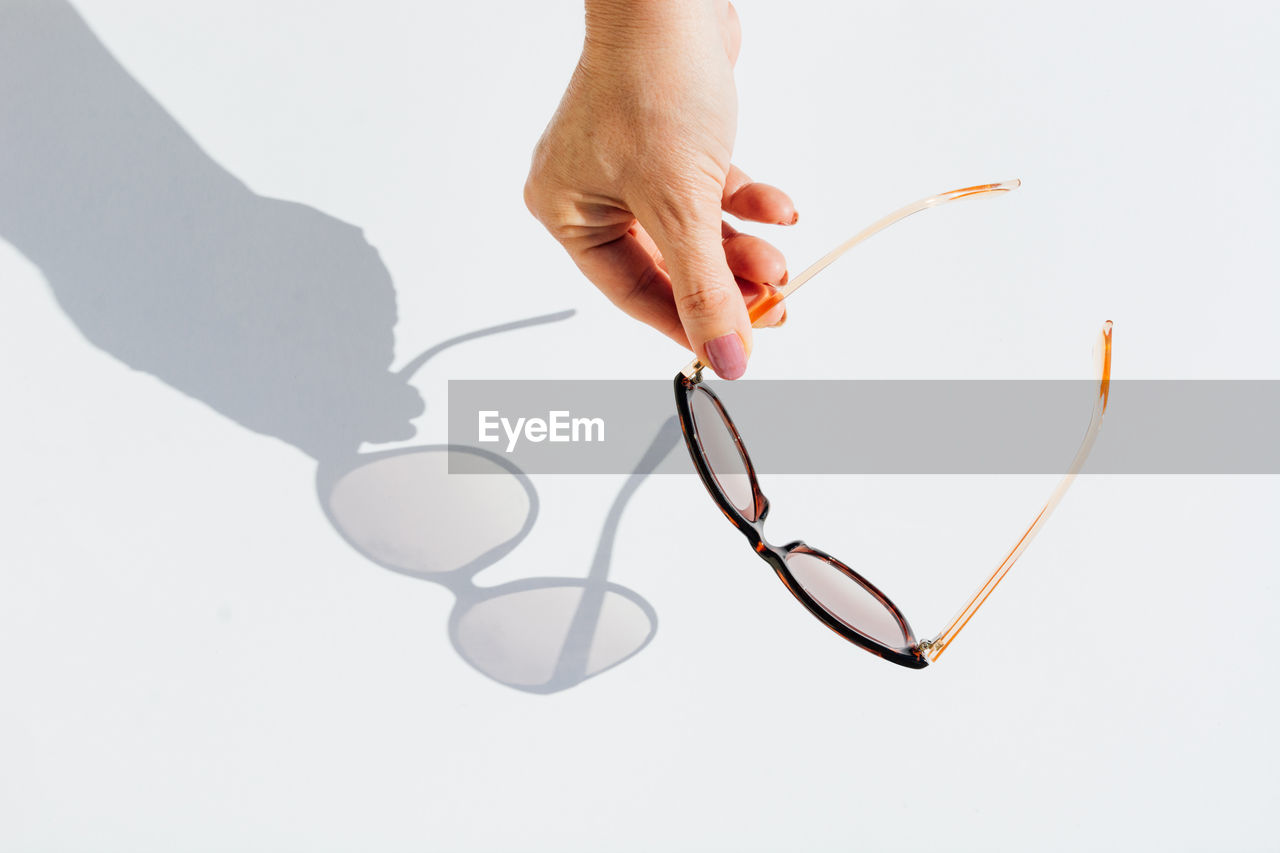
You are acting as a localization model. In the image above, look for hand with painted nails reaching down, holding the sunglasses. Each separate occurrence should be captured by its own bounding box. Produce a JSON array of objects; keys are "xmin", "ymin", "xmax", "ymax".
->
[{"xmin": 525, "ymin": 0, "xmax": 799, "ymax": 379}]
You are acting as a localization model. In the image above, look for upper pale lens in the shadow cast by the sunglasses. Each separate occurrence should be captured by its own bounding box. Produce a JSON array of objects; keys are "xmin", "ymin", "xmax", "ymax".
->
[{"xmin": 328, "ymin": 448, "xmax": 532, "ymax": 576}]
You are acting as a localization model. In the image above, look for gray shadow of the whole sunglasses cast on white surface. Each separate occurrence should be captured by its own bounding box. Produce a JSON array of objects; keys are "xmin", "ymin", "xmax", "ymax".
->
[{"xmin": 316, "ymin": 311, "xmax": 681, "ymax": 693}]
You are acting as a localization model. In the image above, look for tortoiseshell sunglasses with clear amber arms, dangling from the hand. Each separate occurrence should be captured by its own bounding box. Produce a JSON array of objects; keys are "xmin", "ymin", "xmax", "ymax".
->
[{"xmin": 675, "ymin": 181, "xmax": 1111, "ymax": 669}]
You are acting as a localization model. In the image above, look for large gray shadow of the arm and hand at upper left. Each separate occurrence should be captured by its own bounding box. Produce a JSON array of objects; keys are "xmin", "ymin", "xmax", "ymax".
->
[{"xmin": 0, "ymin": 0, "xmax": 422, "ymax": 459}]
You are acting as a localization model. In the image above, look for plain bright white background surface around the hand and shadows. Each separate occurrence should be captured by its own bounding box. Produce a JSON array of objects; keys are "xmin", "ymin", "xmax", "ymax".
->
[{"xmin": 0, "ymin": 0, "xmax": 1280, "ymax": 852}]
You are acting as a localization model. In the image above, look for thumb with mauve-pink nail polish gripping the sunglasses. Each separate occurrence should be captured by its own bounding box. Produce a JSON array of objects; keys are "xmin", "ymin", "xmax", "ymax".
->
[{"xmin": 636, "ymin": 197, "xmax": 751, "ymax": 379}]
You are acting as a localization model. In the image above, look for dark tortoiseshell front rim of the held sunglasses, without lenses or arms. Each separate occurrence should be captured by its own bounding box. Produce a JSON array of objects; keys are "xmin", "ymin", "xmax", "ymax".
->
[{"xmin": 675, "ymin": 370, "xmax": 929, "ymax": 670}]
